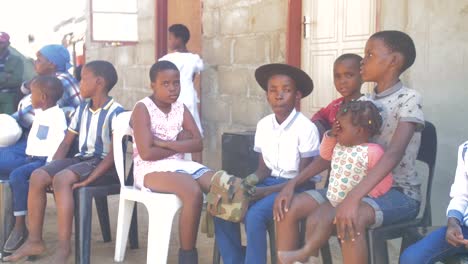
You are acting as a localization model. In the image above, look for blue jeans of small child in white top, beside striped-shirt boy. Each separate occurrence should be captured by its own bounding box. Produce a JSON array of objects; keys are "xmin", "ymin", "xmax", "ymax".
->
[{"xmin": 9, "ymin": 158, "xmax": 46, "ymax": 216}]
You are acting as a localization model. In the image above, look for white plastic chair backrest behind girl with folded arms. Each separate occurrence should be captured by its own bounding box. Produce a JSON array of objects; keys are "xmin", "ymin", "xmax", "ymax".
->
[{"xmin": 112, "ymin": 111, "xmax": 132, "ymax": 186}]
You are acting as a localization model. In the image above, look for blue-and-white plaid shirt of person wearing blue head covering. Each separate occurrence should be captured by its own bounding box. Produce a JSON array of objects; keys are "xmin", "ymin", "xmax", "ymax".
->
[{"xmin": 12, "ymin": 72, "xmax": 83, "ymax": 128}]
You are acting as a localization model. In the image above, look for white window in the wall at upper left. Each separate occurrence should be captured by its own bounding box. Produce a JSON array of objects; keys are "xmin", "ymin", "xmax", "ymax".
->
[{"xmin": 91, "ymin": 0, "xmax": 138, "ymax": 45}]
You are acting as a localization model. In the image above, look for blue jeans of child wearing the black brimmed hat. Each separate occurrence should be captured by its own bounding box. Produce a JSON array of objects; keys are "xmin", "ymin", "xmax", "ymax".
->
[{"xmin": 214, "ymin": 177, "xmax": 294, "ymax": 264}]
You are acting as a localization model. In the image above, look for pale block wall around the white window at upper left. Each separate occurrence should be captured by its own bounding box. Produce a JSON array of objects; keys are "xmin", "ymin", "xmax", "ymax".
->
[{"xmin": 86, "ymin": 0, "xmax": 155, "ymax": 109}]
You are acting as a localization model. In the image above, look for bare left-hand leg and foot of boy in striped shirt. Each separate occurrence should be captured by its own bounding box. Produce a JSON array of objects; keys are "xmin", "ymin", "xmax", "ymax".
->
[{"xmin": 4, "ymin": 169, "xmax": 52, "ymax": 261}]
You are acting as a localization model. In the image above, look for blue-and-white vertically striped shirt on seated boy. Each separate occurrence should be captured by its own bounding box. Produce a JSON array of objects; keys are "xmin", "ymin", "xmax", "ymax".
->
[{"xmin": 68, "ymin": 98, "xmax": 124, "ymax": 158}]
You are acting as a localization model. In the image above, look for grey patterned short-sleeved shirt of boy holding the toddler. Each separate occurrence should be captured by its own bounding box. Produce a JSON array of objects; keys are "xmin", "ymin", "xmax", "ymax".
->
[{"xmin": 369, "ymin": 82, "xmax": 424, "ymax": 201}]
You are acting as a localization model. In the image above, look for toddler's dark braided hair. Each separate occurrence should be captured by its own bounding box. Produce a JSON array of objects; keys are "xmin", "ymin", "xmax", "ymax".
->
[{"xmin": 337, "ymin": 100, "xmax": 383, "ymax": 137}]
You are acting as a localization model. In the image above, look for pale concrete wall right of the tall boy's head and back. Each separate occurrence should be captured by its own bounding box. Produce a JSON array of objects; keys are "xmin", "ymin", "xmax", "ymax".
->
[{"xmin": 380, "ymin": 0, "xmax": 468, "ymax": 224}]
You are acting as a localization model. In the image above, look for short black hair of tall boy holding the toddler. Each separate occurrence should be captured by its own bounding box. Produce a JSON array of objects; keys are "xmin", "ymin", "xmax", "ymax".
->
[{"xmin": 370, "ymin": 30, "xmax": 416, "ymax": 73}]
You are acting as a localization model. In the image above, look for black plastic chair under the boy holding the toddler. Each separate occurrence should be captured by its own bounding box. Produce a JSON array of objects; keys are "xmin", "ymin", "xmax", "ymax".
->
[{"xmin": 321, "ymin": 121, "xmax": 437, "ymax": 264}]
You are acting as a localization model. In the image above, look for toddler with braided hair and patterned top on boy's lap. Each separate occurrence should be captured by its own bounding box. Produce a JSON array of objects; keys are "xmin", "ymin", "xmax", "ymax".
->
[{"xmin": 279, "ymin": 101, "xmax": 393, "ymax": 264}]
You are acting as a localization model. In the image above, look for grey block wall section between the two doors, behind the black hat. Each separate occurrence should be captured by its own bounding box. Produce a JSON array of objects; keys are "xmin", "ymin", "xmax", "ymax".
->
[{"xmin": 201, "ymin": 0, "xmax": 287, "ymax": 168}]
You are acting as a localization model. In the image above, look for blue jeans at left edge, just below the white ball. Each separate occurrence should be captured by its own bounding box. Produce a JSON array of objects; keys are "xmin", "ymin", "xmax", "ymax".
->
[{"xmin": 0, "ymin": 135, "xmax": 27, "ymax": 175}]
